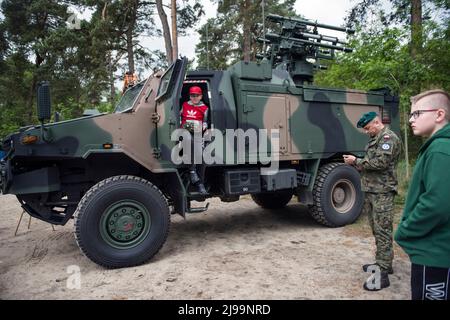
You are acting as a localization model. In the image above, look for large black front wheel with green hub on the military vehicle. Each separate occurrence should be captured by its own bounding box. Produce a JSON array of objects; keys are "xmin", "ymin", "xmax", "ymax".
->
[{"xmin": 75, "ymin": 176, "xmax": 170, "ymax": 268}]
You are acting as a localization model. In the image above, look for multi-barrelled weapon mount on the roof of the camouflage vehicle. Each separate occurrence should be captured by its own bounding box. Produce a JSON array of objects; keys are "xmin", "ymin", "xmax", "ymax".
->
[{"xmin": 257, "ymin": 14, "xmax": 355, "ymax": 85}]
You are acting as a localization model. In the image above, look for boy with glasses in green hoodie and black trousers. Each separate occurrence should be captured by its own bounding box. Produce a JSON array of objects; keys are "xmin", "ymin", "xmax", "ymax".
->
[{"xmin": 395, "ymin": 90, "xmax": 450, "ymax": 300}]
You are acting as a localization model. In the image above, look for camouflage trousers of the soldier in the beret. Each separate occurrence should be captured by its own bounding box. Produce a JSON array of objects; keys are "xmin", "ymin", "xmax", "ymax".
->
[{"xmin": 364, "ymin": 192, "xmax": 395, "ymax": 270}]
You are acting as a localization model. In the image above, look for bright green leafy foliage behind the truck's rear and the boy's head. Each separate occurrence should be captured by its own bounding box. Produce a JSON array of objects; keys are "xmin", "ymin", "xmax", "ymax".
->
[{"xmin": 315, "ymin": 16, "xmax": 450, "ymax": 158}]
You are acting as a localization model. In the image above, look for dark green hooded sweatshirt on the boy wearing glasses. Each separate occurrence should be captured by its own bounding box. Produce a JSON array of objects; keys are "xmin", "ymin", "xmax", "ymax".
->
[{"xmin": 395, "ymin": 124, "xmax": 450, "ymax": 268}]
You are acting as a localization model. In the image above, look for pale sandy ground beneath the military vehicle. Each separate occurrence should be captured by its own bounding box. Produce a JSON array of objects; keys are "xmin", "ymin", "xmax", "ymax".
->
[{"xmin": 0, "ymin": 196, "xmax": 410, "ymax": 300}]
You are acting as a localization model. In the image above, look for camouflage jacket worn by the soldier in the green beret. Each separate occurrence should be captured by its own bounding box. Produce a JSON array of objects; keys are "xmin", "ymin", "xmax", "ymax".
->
[{"xmin": 355, "ymin": 127, "xmax": 402, "ymax": 193}]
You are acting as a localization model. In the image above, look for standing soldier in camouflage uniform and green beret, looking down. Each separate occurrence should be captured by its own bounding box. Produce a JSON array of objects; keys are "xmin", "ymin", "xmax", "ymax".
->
[{"xmin": 344, "ymin": 112, "xmax": 401, "ymax": 291}]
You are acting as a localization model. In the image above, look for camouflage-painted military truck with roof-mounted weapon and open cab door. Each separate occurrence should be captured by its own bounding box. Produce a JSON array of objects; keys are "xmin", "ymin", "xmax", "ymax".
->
[{"xmin": 1, "ymin": 15, "xmax": 399, "ymax": 268}]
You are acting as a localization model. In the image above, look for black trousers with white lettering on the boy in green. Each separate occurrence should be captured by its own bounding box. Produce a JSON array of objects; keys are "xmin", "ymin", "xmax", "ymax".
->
[{"xmin": 411, "ymin": 264, "xmax": 450, "ymax": 300}]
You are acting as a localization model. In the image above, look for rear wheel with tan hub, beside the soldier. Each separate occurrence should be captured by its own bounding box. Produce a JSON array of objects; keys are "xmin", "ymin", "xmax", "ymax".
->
[{"xmin": 310, "ymin": 162, "xmax": 364, "ymax": 227}]
